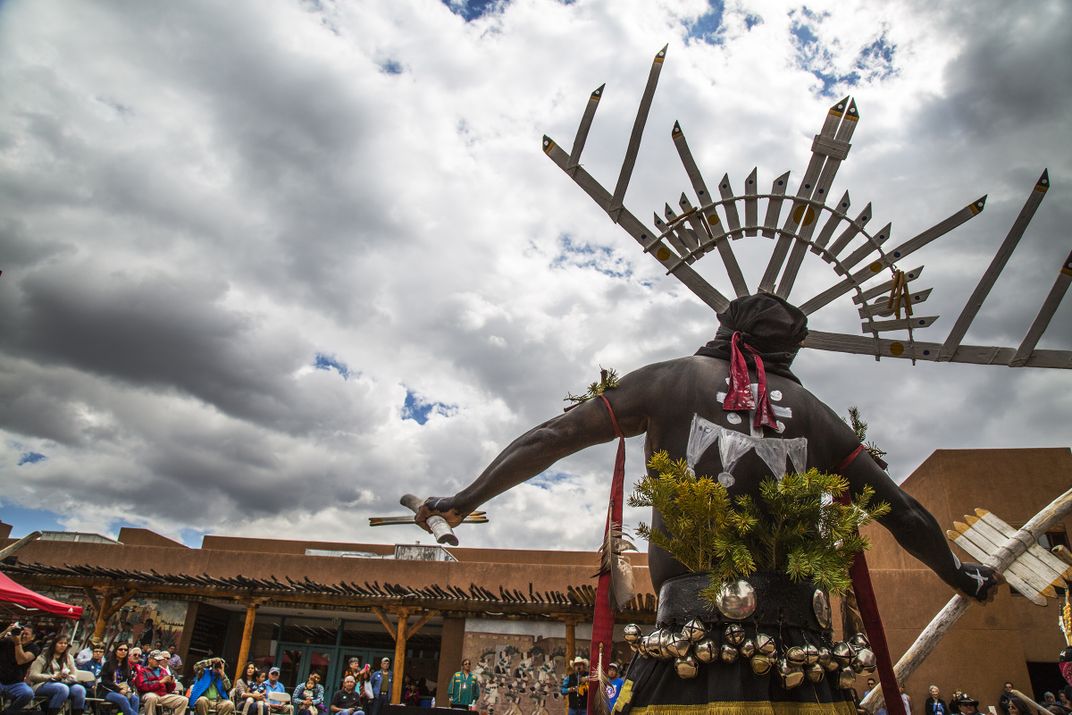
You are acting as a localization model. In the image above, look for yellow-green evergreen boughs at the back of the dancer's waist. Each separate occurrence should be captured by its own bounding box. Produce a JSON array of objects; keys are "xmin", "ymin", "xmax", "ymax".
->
[{"xmin": 629, "ymin": 451, "xmax": 890, "ymax": 601}]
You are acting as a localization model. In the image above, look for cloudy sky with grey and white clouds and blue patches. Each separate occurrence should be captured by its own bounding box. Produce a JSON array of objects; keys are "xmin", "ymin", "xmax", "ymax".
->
[{"xmin": 0, "ymin": 0, "xmax": 1072, "ymax": 549}]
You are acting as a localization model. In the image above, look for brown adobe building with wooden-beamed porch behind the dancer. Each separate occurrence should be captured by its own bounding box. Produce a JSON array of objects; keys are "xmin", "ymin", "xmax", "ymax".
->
[{"xmin": 0, "ymin": 448, "xmax": 1072, "ymax": 713}]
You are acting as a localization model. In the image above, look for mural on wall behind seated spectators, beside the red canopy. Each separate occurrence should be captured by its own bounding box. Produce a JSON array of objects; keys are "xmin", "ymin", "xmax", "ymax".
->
[{"xmin": 43, "ymin": 592, "xmax": 188, "ymax": 650}]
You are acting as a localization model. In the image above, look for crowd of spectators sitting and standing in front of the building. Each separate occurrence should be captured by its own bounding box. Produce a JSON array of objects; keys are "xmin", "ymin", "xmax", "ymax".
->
[{"xmin": 10, "ymin": 623, "xmax": 1072, "ymax": 715}]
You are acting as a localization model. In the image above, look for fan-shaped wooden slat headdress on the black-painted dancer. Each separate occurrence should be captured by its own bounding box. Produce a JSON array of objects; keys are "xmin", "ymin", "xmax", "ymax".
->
[{"xmin": 544, "ymin": 47, "xmax": 1072, "ymax": 369}]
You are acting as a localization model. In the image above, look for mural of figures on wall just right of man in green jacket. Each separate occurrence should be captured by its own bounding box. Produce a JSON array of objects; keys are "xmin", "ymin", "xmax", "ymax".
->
[{"xmin": 462, "ymin": 632, "xmax": 629, "ymax": 715}]
